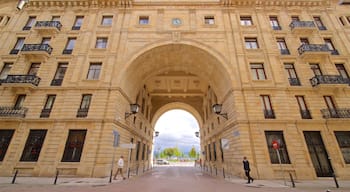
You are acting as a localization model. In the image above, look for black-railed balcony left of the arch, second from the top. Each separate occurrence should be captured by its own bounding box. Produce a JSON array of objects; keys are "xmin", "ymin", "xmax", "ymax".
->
[{"xmin": 21, "ymin": 44, "xmax": 52, "ymax": 59}]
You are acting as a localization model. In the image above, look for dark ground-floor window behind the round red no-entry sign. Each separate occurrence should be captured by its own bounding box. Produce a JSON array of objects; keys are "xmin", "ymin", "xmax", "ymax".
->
[{"xmin": 265, "ymin": 131, "xmax": 290, "ymax": 164}]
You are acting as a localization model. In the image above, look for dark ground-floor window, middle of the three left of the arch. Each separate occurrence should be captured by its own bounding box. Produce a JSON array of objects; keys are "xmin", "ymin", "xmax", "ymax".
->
[{"xmin": 21, "ymin": 130, "xmax": 47, "ymax": 162}]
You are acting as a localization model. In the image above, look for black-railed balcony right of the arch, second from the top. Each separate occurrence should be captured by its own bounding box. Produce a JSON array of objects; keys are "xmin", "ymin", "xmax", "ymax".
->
[{"xmin": 298, "ymin": 44, "xmax": 332, "ymax": 59}]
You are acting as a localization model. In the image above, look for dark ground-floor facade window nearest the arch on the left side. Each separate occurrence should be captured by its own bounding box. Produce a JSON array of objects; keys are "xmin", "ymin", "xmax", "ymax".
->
[{"xmin": 62, "ymin": 130, "xmax": 86, "ymax": 162}]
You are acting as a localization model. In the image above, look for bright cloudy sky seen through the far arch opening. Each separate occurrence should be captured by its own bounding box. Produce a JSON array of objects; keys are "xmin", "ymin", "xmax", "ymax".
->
[{"xmin": 154, "ymin": 110, "xmax": 200, "ymax": 154}]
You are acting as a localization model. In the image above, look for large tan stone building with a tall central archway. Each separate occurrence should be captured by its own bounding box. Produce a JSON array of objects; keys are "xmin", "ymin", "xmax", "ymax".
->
[{"xmin": 0, "ymin": 0, "xmax": 350, "ymax": 179}]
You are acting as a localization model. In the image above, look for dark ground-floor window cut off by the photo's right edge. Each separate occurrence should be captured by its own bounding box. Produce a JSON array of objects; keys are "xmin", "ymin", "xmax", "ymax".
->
[{"xmin": 334, "ymin": 131, "xmax": 350, "ymax": 164}]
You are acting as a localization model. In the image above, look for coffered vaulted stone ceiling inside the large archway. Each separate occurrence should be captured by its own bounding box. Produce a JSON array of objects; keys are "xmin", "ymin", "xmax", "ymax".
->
[{"xmin": 121, "ymin": 44, "xmax": 231, "ymax": 123}]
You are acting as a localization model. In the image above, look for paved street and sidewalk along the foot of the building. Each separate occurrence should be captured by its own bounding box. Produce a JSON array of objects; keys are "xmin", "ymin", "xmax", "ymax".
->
[{"xmin": 0, "ymin": 165, "xmax": 350, "ymax": 192}]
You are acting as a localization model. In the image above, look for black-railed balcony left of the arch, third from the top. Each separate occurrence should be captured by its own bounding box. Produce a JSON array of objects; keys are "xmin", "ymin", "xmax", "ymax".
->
[{"xmin": 1, "ymin": 75, "xmax": 41, "ymax": 89}]
